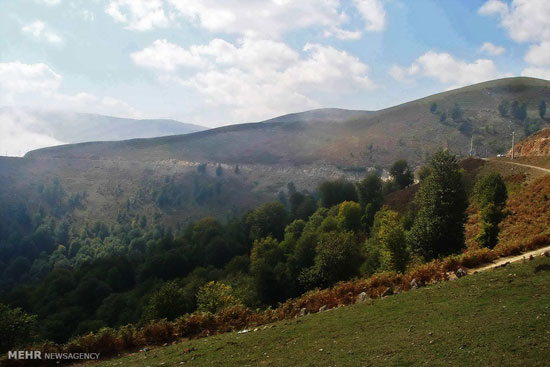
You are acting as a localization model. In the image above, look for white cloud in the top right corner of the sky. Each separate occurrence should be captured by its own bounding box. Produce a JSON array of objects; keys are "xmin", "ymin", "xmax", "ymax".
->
[{"xmin": 479, "ymin": 0, "xmax": 550, "ymax": 42}]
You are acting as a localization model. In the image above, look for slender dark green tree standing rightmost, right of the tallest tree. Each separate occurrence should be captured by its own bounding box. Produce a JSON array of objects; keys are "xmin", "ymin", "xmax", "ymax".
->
[{"xmin": 474, "ymin": 173, "xmax": 508, "ymax": 248}]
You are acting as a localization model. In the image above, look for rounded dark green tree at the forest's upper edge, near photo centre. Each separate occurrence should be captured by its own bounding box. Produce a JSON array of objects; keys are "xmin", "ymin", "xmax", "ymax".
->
[{"xmin": 245, "ymin": 202, "xmax": 288, "ymax": 241}]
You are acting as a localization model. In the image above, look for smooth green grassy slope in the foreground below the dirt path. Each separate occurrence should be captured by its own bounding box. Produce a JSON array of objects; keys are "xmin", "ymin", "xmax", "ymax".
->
[{"xmin": 88, "ymin": 257, "xmax": 550, "ymax": 367}]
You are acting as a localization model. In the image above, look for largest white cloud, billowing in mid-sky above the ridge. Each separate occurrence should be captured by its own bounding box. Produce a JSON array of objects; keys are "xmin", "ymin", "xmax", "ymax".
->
[{"xmin": 132, "ymin": 38, "xmax": 375, "ymax": 122}]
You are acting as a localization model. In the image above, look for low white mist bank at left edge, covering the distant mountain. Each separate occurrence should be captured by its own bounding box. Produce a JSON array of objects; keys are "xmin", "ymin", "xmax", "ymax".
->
[{"xmin": 0, "ymin": 109, "xmax": 64, "ymax": 156}]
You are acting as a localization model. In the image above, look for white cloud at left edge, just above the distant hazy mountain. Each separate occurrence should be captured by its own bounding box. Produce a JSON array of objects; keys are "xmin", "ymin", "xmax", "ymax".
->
[{"xmin": 0, "ymin": 62, "xmax": 140, "ymax": 117}]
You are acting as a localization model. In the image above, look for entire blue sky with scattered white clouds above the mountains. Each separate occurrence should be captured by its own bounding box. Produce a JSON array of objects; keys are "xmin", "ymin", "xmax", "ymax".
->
[{"xmin": 0, "ymin": 0, "xmax": 550, "ymax": 127}]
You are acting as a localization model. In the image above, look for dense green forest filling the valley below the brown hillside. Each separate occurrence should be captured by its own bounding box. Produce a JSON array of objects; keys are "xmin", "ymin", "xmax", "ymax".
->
[{"xmin": 0, "ymin": 151, "xmax": 507, "ymax": 352}]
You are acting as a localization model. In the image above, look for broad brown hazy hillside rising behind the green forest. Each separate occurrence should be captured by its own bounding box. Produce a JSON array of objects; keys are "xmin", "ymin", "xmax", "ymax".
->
[{"xmin": 4, "ymin": 78, "xmax": 550, "ymax": 225}]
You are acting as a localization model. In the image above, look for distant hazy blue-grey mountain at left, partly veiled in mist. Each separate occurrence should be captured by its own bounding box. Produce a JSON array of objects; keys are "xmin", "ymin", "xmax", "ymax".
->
[{"xmin": 0, "ymin": 108, "xmax": 207, "ymax": 155}]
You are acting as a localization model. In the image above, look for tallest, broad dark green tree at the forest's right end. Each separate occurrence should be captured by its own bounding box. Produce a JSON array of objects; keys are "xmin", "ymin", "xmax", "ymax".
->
[{"xmin": 409, "ymin": 151, "xmax": 468, "ymax": 260}]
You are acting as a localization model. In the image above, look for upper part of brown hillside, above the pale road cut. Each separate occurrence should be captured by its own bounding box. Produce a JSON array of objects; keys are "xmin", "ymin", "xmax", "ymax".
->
[{"xmin": 28, "ymin": 78, "xmax": 550, "ymax": 167}]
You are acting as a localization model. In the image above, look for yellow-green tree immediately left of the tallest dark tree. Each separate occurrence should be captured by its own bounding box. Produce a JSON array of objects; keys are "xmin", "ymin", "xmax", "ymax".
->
[{"xmin": 367, "ymin": 210, "xmax": 410, "ymax": 273}]
